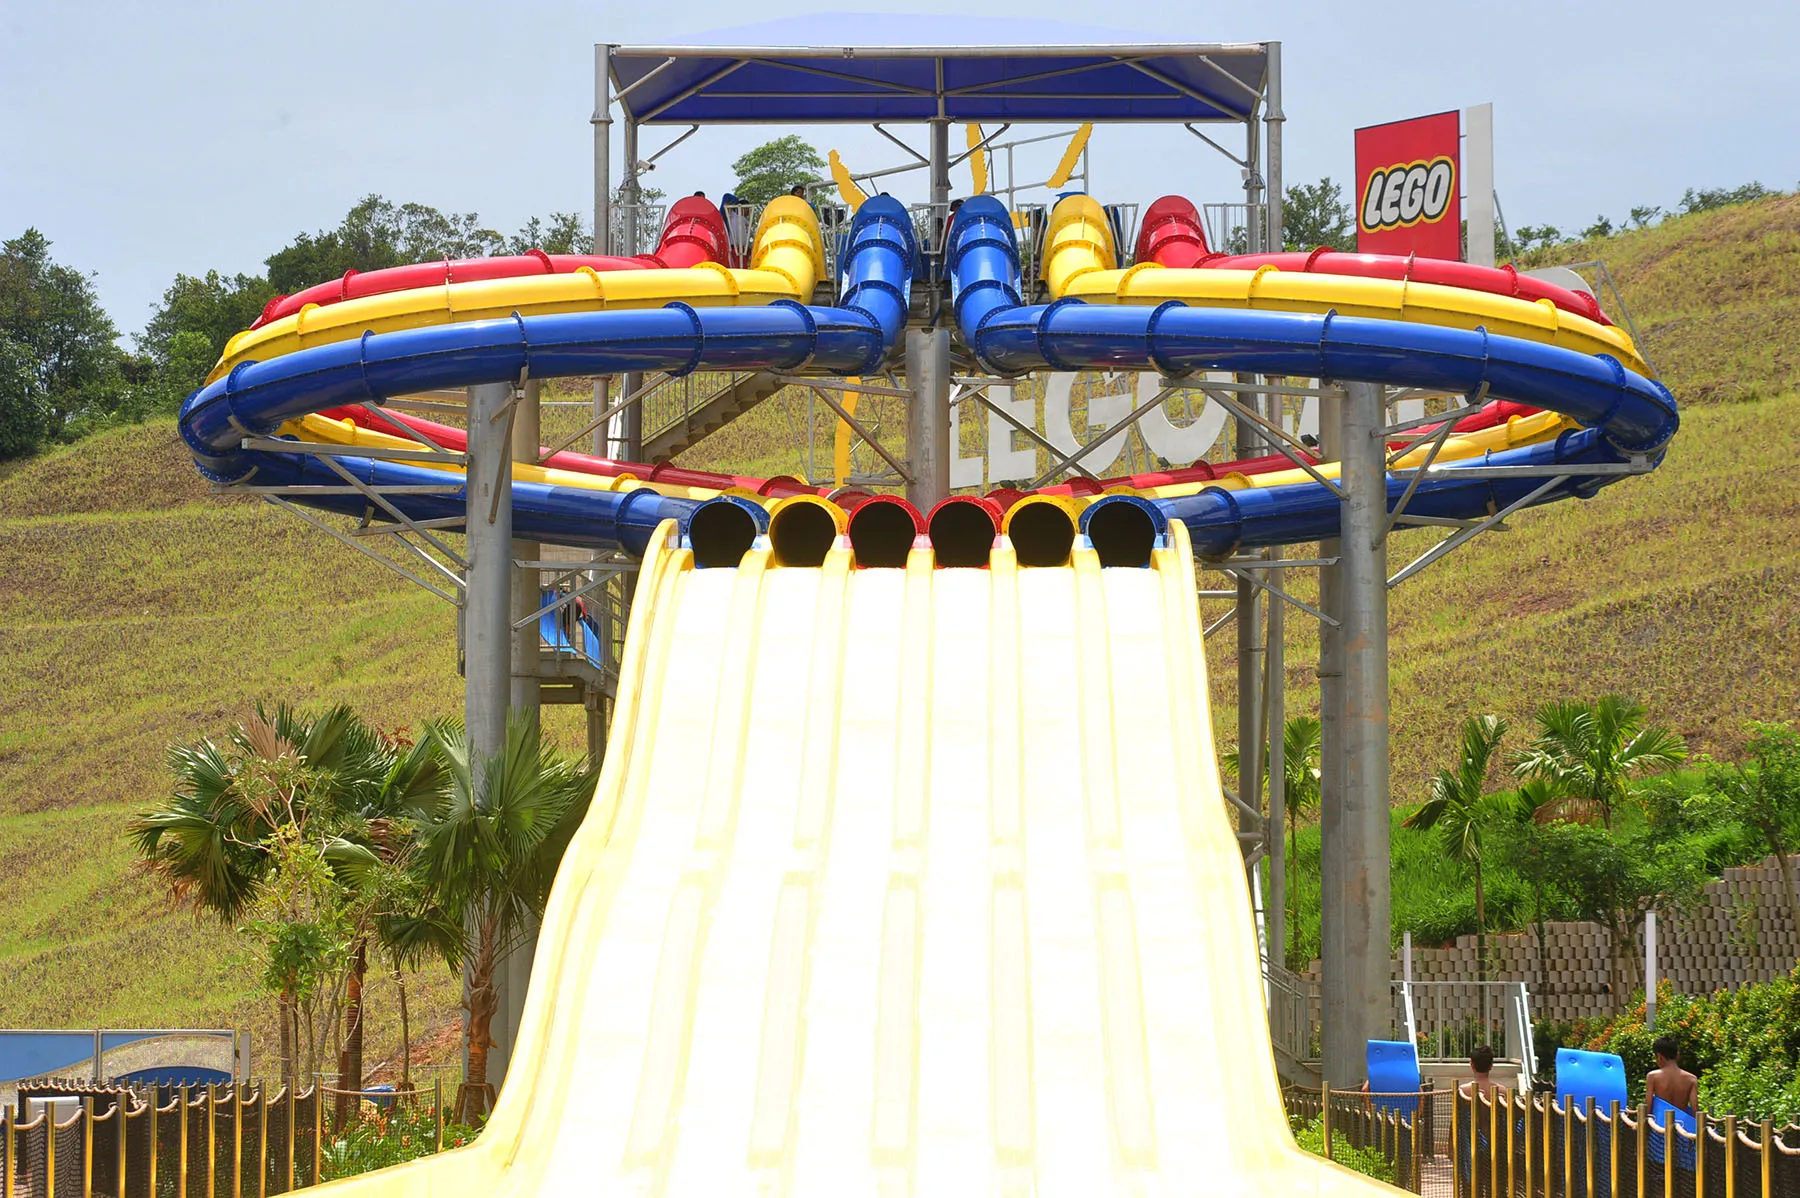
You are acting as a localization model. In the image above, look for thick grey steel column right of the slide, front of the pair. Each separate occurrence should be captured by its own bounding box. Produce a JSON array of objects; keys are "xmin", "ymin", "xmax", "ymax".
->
[{"xmin": 1319, "ymin": 383, "xmax": 1391, "ymax": 1086}]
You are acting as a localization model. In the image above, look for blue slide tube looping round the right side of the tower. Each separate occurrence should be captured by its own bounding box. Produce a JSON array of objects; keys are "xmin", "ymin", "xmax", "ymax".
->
[{"xmin": 949, "ymin": 196, "xmax": 1679, "ymax": 554}]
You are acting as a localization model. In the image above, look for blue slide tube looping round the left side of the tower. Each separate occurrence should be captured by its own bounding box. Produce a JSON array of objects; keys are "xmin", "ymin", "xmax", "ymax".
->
[{"xmin": 180, "ymin": 196, "xmax": 914, "ymax": 552}]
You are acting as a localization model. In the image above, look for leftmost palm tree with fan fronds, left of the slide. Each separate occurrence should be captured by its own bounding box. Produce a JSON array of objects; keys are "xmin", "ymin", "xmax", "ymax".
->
[{"xmin": 128, "ymin": 703, "xmax": 380, "ymax": 1076}]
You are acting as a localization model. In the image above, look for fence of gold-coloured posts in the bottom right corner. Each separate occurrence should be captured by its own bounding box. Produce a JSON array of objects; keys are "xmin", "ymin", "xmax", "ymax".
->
[{"xmin": 1451, "ymin": 1090, "xmax": 1800, "ymax": 1198}]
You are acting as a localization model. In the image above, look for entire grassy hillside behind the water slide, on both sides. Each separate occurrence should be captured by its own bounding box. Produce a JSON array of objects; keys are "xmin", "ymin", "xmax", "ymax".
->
[{"xmin": 0, "ymin": 196, "xmax": 1800, "ymax": 1059}]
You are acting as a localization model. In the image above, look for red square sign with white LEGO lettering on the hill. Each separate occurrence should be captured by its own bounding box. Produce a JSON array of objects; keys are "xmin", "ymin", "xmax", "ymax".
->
[{"xmin": 1355, "ymin": 112, "xmax": 1462, "ymax": 259}]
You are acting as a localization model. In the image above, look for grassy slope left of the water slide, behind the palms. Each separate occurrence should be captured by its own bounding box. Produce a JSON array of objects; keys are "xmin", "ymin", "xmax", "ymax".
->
[{"xmin": 0, "ymin": 421, "xmax": 507, "ymax": 1059}]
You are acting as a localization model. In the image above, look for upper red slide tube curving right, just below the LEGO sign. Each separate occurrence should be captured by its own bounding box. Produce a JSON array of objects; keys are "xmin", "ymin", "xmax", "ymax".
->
[{"xmin": 1138, "ymin": 196, "xmax": 1613, "ymax": 324}]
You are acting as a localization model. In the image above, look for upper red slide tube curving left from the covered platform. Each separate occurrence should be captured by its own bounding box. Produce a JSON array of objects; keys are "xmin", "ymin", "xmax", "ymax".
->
[{"xmin": 250, "ymin": 196, "xmax": 729, "ymax": 329}]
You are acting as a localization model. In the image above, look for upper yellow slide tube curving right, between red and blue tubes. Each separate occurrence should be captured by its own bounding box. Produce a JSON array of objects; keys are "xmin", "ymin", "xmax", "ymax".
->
[{"xmin": 1044, "ymin": 196, "xmax": 1651, "ymax": 376}]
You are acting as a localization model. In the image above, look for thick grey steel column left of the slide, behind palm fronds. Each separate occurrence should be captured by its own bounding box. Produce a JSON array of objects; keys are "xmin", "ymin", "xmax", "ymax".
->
[{"xmin": 463, "ymin": 383, "xmax": 513, "ymax": 1088}]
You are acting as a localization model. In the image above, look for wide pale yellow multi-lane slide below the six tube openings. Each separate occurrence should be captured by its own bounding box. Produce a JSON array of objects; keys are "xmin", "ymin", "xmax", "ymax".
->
[{"xmin": 309, "ymin": 523, "xmax": 1399, "ymax": 1198}]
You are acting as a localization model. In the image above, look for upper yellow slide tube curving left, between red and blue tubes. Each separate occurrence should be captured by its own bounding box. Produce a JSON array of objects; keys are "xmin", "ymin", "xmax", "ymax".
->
[{"xmin": 207, "ymin": 196, "xmax": 824, "ymax": 383}]
